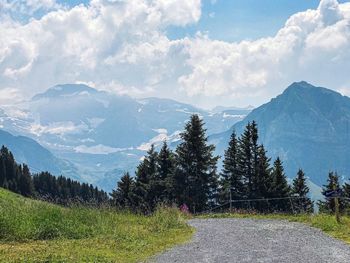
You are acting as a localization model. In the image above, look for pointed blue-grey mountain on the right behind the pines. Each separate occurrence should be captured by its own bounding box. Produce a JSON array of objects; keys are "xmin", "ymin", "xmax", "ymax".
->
[{"xmin": 211, "ymin": 81, "xmax": 350, "ymax": 186}]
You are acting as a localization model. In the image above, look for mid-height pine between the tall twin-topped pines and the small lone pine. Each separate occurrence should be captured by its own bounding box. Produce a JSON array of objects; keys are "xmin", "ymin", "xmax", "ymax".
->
[{"xmin": 272, "ymin": 157, "xmax": 291, "ymax": 212}]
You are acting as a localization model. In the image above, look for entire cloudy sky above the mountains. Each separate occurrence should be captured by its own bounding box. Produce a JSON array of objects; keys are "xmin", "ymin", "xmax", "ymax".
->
[{"xmin": 0, "ymin": 0, "xmax": 350, "ymax": 108}]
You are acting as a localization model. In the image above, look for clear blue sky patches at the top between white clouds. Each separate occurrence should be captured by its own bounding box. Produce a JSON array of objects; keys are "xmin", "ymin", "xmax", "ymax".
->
[{"xmin": 57, "ymin": 0, "xmax": 348, "ymax": 41}]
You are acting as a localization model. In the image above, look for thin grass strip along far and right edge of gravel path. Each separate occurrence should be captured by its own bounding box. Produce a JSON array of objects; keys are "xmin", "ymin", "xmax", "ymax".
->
[{"xmin": 196, "ymin": 213, "xmax": 350, "ymax": 244}]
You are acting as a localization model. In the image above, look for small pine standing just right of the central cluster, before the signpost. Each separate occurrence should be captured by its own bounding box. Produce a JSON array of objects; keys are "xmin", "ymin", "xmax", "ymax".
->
[{"xmin": 292, "ymin": 169, "xmax": 313, "ymax": 213}]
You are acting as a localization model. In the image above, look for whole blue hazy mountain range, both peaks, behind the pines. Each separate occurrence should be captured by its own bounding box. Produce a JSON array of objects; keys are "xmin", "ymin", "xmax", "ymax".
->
[{"xmin": 0, "ymin": 81, "xmax": 350, "ymax": 197}]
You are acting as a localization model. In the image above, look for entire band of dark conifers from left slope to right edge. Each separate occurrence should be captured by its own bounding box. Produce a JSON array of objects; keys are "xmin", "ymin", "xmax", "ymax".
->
[{"xmin": 0, "ymin": 115, "xmax": 350, "ymax": 213}]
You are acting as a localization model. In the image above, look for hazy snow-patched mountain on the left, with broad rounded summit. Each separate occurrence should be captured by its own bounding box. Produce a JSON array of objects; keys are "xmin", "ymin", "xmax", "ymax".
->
[{"xmin": 0, "ymin": 84, "xmax": 250, "ymax": 190}]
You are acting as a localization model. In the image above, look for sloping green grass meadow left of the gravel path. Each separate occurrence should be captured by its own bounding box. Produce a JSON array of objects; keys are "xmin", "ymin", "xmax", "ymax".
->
[{"xmin": 0, "ymin": 189, "xmax": 193, "ymax": 262}]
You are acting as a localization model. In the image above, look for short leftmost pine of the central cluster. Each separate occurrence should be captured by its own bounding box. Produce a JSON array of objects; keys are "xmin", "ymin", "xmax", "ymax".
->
[{"xmin": 111, "ymin": 173, "xmax": 134, "ymax": 209}]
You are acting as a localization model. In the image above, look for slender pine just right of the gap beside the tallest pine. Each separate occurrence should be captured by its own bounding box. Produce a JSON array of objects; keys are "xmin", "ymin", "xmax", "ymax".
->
[{"xmin": 220, "ymin": 131, "xmax": 243, "ymax": 206}]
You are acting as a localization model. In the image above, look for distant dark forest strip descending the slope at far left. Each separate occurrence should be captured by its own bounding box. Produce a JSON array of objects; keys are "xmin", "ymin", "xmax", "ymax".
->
[{"xmin": 0, "ymin": 146, "xmax": 109, "ymax": 205}]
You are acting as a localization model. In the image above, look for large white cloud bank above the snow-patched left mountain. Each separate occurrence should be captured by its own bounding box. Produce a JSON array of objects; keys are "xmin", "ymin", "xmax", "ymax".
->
[{"xmin": 0, "ymin": 0, "xmax": 201, "ymax": 101}]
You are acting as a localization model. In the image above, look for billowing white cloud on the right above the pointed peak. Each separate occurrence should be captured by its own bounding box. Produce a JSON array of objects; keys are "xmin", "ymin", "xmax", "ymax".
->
[{"xmin": 179, "ymin": 0, "xmax": 350, "ymax": 103}]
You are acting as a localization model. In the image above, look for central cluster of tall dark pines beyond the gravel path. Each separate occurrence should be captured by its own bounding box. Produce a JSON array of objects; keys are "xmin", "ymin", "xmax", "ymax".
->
[{"xmin": 111, "ymin": 115, "xmax": 350, "ymax": 213}]
